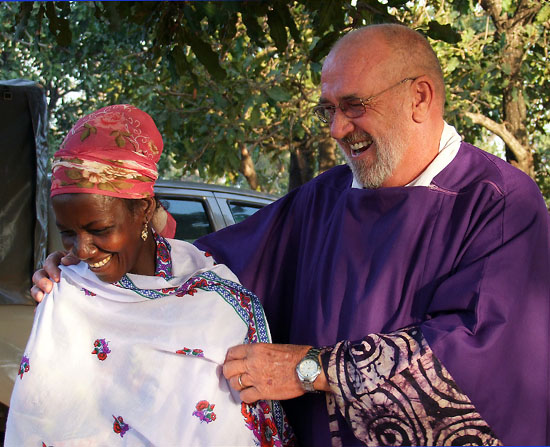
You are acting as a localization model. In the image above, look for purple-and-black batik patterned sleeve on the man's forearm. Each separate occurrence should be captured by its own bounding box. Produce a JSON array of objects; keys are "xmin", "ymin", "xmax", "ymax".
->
[{"xmin": 321, "ymin": 327, "xmax": 502, "ymax": 446}]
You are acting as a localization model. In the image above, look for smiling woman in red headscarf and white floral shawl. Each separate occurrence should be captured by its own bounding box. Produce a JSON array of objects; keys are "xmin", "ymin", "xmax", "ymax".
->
[{"xmin": 5, "ymin": 105, "xmax": 291, "ymax": 446}]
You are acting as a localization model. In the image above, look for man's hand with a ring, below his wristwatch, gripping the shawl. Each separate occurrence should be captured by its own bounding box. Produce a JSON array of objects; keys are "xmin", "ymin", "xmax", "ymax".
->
[{"xmin": 223, "ymin": 343, "xmax": 330, "ymax": 403}]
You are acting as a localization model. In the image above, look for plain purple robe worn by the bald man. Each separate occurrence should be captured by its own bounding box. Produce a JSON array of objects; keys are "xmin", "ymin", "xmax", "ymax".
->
[{"xmin": 196, "ymin": 143, "xmax": 550, "ymax": 447}]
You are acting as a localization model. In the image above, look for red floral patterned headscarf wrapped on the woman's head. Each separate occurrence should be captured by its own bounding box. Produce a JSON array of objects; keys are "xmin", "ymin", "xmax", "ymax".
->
[{"xmin": 51, "ymin": 104, "xmax": 163, "ymax": 199}]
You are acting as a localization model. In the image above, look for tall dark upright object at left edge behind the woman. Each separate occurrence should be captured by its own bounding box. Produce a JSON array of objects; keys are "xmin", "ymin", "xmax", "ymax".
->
[{"xmin": 0, "ymin": 79, "xmax": 48, "ymax": 304}]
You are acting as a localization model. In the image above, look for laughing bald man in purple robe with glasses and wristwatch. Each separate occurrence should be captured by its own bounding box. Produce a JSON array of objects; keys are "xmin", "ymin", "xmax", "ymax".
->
[{"xmin": 35, "ymin": 25, "xmax": 550, "ymax": 447}]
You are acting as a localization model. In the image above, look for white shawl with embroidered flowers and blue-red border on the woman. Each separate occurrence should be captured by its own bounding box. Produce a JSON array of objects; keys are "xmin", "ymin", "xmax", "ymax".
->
[{"xmin": 5, "ymin": 237, "xmax": 292, "ymax": 447}]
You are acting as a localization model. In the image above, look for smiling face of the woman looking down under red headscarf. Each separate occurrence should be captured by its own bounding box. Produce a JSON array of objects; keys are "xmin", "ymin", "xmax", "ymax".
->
[{"xmin": 52, "ymin": 194, "xmax": 155, "ymax": 283}]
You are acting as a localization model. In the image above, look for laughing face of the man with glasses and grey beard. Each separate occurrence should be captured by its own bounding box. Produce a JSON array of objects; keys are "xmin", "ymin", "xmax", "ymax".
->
[{"xmin": 321, "ymin": 40, "xmax": 414, "ymax": 188}]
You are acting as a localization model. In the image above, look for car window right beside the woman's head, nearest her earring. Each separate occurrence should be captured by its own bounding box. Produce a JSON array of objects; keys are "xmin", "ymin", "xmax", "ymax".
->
[{"xmin": 161, "ymin": 197, "xmax": 214, "ymax": 242}]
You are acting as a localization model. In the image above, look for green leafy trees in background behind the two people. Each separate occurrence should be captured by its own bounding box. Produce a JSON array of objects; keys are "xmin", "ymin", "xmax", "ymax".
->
[{"xmin": 0, "ymin": 0, "xmax": 550, "ymax": 201}]
